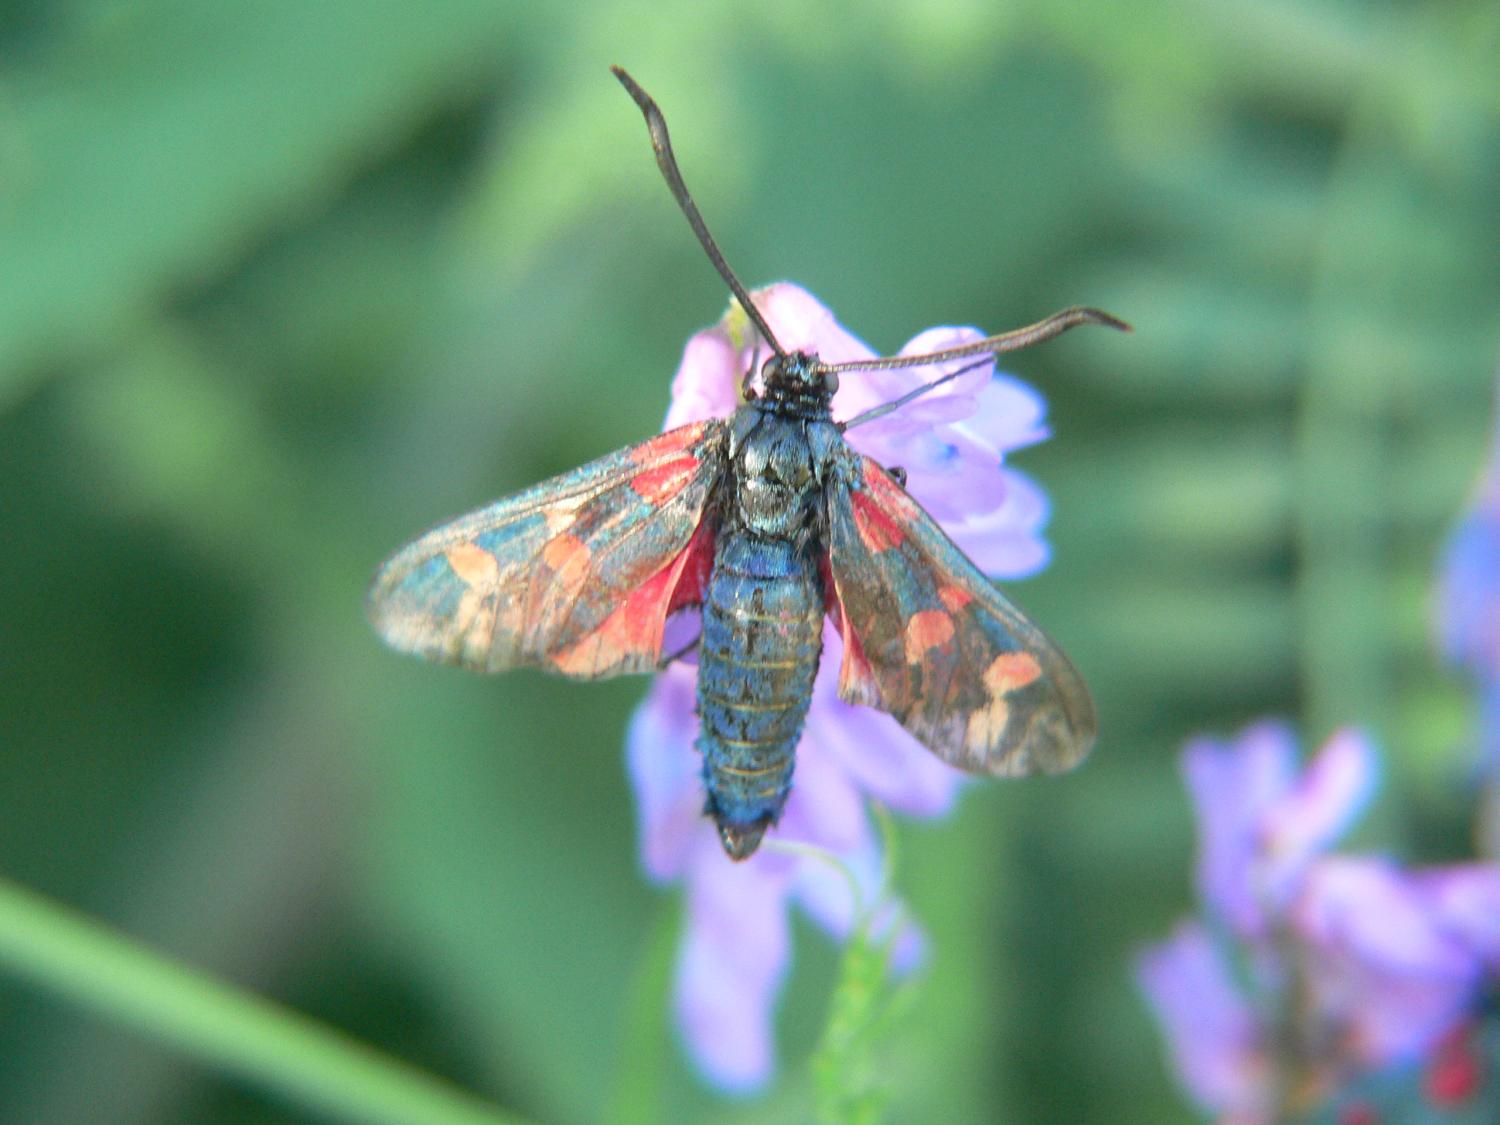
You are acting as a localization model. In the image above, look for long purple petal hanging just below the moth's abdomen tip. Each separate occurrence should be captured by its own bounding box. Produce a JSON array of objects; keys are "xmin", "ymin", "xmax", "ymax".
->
[{"xmin": 677, "ymin": 846, "xmax": 791, "ymax": 1094}]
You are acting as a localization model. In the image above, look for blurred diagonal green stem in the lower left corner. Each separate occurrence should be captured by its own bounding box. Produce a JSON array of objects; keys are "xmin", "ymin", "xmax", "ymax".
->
[{"xmin": 0, "ymin": 879, "xmax": 519, "ymax": 1125}]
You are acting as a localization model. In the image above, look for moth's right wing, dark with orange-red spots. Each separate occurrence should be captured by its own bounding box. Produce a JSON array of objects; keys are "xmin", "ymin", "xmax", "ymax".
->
[{"xmin": 828, "ymin": 447, "xmax": 1097, "ymax": 776}]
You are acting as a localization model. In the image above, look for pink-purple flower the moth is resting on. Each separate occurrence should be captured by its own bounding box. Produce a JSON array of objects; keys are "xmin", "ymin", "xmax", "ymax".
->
[{"xmin": 629, "ymin": 282, "xmax": 1047, "ymax": 1091}]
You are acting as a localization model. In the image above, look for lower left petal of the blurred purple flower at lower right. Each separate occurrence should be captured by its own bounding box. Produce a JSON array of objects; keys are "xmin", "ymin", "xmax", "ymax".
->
[{"xmin": 1136, "ymin": 923, "xmax": 1271, "ymax": 1121}]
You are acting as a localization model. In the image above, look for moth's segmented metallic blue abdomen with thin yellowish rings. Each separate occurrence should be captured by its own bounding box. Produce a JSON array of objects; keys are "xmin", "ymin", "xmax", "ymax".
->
[{"xmin": 698, "ymin": 533, "xmax": 824, "ymax": 860}]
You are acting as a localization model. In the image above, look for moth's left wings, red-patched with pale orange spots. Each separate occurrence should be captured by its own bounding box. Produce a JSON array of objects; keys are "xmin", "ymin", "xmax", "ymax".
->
[{"xmin": 368, "ymin": 420, "xmax": 728, "ymax": 680}]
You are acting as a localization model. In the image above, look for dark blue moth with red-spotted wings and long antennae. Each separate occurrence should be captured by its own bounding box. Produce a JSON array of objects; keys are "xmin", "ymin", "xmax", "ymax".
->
[{"xmin": 368, "ymin": 68, "xmax": 1128, "ymax": 860}]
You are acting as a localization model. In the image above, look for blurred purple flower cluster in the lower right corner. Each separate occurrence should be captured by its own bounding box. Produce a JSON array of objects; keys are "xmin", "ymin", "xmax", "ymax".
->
[{"xmin": 1139, "ymin": 723, "xmax": 1500, "ymax": 1122}]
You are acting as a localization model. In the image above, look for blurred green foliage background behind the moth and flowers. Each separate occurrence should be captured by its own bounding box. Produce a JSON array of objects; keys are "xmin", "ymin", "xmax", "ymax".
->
[{"xmin": 0, "ymin": 0, "xmax": 1500, "ymax": 1122}]
